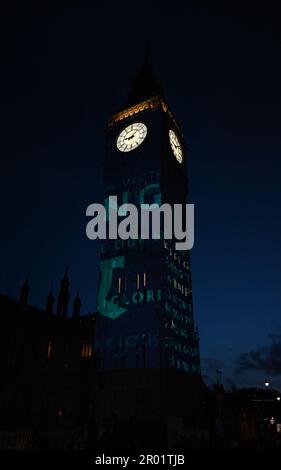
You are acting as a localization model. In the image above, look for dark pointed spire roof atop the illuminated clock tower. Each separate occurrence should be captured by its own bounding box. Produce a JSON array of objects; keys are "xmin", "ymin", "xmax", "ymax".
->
[{"xmin": 127, "ymin": 48, "xmax": 164, "ymax": 105}]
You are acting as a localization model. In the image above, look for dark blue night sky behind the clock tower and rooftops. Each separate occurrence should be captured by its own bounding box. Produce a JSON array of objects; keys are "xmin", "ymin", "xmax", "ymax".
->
[{"xmin": 0, "ymin": 1, "xmax": 281, "ymax": 388}]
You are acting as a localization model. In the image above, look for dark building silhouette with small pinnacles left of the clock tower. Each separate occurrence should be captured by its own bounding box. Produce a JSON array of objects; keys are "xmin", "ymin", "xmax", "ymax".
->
[{"xmin": 0, "ymin": 273, "xmax": 97, "ymax": 449}]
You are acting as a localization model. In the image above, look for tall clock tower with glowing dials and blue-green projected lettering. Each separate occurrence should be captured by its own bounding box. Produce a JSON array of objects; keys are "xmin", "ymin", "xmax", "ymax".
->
[{"xmin": 95, "ymin": 55, "xmax": 200, "ymax": 375}]
